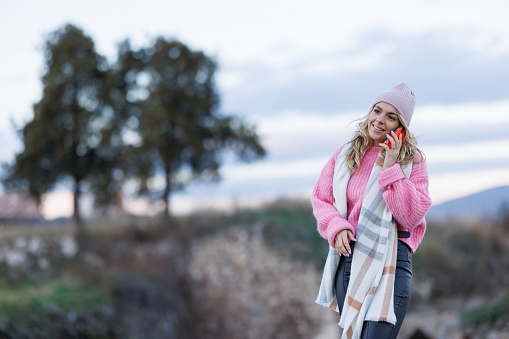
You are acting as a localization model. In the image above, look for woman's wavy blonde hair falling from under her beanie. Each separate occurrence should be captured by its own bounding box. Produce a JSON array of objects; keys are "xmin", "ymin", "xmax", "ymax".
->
[{"xmin": 346, "ymin": 106, "xmax": 424, "ymax": 173}]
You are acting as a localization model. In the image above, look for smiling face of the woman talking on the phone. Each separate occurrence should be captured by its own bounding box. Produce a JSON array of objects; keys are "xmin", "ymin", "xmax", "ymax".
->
[{"xmin": 368, "ymin": 102, "xmax": 400, "ymax": 146}]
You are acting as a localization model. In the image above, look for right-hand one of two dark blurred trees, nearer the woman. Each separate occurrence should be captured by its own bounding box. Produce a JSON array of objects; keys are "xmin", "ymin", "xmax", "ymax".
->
[{"xmin": 117, "ymin": 38, "xmax": 265, "ymax": 218}]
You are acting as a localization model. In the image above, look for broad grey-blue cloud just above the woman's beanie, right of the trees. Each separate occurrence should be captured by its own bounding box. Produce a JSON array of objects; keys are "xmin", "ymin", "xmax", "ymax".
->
[{"xmin": 219, "ymin": 30, "xmax": 509, "ymax": 116}]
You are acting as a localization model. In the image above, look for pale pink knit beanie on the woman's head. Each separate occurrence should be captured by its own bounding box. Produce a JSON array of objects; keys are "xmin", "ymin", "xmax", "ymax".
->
[{"xmin": 371, "ymin": 82, "xmax": 416, "ymax": 126}]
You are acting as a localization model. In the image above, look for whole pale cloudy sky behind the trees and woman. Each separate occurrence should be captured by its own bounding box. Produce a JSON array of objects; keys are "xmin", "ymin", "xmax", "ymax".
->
[{"xmin": 0, "ymin": 0, "xmax": 509, "ymax": 218}]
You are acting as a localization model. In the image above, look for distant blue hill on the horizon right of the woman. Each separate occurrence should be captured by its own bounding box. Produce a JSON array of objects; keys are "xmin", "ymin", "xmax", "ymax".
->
[{"xmin": 426, "ymin": 186, "xmax": 509, "ymax": 220}]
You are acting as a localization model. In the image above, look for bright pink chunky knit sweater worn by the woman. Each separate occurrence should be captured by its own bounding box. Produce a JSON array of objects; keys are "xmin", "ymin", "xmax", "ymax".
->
[{"xmin": 311, "ymin": 145, "xmax": 431, "ymax": 252}]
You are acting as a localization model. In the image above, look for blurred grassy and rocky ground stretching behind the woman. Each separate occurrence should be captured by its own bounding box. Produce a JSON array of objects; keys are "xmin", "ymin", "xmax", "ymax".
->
[{"xmin": 0, "ymin": 200, "xmax": 509, "ymax": 339}]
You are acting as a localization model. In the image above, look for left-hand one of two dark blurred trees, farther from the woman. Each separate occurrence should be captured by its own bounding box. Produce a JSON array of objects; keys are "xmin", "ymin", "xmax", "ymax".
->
[{"xmin": 4, "ymin": 25, "xmax": 113, "ymax": 244}]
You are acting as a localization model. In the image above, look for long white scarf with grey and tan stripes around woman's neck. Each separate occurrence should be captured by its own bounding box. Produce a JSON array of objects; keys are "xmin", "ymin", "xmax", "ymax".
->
[{"xmin": 316, "ymin": 144, "xmax": 412, "ymax": 339}]
